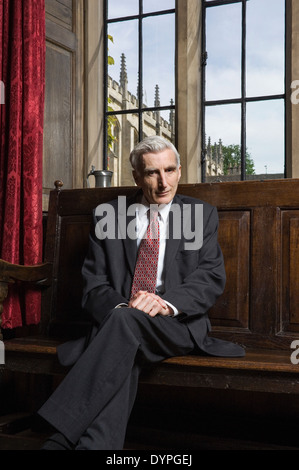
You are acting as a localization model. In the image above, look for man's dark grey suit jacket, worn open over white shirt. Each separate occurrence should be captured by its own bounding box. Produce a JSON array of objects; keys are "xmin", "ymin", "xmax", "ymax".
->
[{"xmin": 59, "ymin": 191, "xmax": 244, "ymax": 365}]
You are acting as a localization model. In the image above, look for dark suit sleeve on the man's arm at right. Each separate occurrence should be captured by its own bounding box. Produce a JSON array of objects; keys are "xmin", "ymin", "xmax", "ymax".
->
[{"xmin": 162, "ymin": 207, "xmax": 226, "ymax": 319}]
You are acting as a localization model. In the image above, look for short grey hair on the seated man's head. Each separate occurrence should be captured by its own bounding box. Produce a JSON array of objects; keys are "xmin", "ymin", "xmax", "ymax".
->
[{"xmin": 130, "ymin": 135, "xmax": 180, "ymax": 170}]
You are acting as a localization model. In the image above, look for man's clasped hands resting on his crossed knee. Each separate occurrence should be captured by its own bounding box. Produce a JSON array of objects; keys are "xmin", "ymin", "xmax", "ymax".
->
[{"xmin": 128, "ymin": 291, "xmax": 173, "ymax": 317}]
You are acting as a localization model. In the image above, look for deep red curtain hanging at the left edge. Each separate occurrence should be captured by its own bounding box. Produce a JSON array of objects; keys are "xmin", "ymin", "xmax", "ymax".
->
[{"xmin": 0, "ymin": 0, "xmax": 45, "ymax": 328}]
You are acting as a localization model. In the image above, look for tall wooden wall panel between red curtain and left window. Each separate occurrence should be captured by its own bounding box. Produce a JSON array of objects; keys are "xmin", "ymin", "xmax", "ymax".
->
[{"xmin": 43, "ymin": 0, "xmax": 84, "ymax": 211}]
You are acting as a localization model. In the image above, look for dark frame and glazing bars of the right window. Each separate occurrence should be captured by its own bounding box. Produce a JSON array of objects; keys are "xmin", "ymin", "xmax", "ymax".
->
[{"xmin": 201, "ymin": 0, "xmax": 288, "ymax": 183}]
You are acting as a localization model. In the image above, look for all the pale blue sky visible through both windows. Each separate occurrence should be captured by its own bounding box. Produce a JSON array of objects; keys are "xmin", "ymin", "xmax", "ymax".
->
[{"xmin": 109, "ymin": 0, "xmax": 284, "ymax": 174}]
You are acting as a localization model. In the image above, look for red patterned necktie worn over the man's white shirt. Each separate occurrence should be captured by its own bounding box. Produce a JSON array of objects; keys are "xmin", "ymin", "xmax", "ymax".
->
[{"xmin": 131, "ymin": 211, "xmax": 160, "ymax": 297}]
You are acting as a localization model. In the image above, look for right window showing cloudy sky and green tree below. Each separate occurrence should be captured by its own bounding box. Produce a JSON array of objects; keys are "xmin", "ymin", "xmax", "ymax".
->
[{"xmin": 202, "ymin": 0, "xmax": 285, "ymax": 181}]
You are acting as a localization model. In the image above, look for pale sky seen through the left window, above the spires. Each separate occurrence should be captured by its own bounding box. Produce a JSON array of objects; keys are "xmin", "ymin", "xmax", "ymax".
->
[{"xmin": 108, "ymin": 0, "xmax": 175, "ymax": 112}]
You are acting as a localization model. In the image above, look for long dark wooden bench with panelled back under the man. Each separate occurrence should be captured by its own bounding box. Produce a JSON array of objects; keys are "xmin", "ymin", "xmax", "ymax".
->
[{"xmin": 0, "ymin": 179, "xmax": 299, "ymax": 449}]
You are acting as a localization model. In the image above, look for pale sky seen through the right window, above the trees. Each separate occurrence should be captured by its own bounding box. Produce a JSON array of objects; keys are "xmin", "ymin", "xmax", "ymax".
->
[{"xmin": 206, "ymin": 0, "xmax": 284, "ymax": 174}]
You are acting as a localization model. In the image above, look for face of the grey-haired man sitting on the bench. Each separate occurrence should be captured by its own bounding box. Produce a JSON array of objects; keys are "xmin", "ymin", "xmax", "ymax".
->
[{"xmin": 133, "ymin": 149, "xmax": 181, "ymax": 204}]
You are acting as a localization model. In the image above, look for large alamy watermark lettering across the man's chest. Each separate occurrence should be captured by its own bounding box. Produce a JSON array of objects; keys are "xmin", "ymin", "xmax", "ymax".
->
[{"xmin": 95, "ymin": 196, "xmax": 203, "ymax": 250}]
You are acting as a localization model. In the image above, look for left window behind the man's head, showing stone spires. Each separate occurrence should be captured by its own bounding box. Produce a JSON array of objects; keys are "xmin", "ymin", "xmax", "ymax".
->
[{"xmin": 104, "ymin": 0, "xmax": 176, "ymax": 185}]
